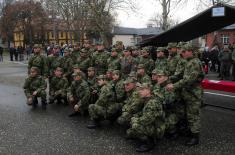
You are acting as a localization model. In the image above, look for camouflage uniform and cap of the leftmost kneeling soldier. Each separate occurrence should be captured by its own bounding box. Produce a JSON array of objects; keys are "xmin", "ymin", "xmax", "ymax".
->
[{"xmin": 23, "ymin": 67, "xmax": 47, "ymax": 107}]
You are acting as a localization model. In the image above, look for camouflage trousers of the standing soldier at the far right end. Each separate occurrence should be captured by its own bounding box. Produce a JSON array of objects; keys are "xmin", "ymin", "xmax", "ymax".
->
[{"xmin": 183, "ymin": 86, "xmax": 203, "ymax": 133}]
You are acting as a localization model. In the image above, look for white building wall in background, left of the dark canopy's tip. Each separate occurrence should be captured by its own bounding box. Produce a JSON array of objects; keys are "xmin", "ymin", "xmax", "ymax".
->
[{"xmin": 113, "ymin": 35, "xmax": 136, "ymax": 47}]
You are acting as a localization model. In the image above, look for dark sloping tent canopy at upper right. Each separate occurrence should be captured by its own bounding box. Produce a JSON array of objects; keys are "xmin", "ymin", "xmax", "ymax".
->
[{"xmin": 140, "ymin": 3, "xmax": 235, "ymax": 47}]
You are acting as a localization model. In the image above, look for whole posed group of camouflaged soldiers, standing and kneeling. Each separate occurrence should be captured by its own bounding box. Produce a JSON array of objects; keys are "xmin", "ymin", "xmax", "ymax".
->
[{"xmin": 24, "ymin": 41, "xmax": 204, "ymax": 152}]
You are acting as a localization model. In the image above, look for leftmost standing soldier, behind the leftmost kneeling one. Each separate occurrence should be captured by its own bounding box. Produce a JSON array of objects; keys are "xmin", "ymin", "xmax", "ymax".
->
[{"xmin": 28, "ymin": 44, "xmax": 48, "ymax": 77}]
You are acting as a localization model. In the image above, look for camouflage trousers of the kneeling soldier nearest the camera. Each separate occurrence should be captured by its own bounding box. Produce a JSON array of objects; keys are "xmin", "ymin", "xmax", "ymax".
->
[{"xmin": 127, "ymin": 118, "xmax": 166, "ymax": 140}]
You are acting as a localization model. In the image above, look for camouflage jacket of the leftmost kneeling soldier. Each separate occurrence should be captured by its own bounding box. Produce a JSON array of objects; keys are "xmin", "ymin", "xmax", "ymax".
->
[{"xmin": 23, "ymin": 76, "xmax": 47, "ymax": 97}]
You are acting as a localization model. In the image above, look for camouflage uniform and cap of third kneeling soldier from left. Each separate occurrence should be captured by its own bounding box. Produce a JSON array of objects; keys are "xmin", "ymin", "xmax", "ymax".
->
[{"xmin": 67, "ymin": 73, "xmax": 90, "ymax": 114}]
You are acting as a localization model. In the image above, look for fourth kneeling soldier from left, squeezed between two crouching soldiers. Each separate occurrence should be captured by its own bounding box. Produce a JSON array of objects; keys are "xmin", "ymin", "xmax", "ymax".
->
[{"xmin": 87, "ymin": 67, "xmax": 98, "ymax": 104}]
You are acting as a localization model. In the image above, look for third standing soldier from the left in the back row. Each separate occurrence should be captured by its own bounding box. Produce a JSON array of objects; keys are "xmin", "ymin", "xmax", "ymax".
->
[{"xmin": 61, "ymin": 48, "xmax": 73, "ymax": 81}]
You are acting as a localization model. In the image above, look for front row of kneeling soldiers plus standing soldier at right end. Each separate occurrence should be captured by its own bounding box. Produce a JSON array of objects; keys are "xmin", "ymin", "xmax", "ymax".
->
[{"xmin": 24, "ymin": 44, "xmax": 202, "ymax": 152}]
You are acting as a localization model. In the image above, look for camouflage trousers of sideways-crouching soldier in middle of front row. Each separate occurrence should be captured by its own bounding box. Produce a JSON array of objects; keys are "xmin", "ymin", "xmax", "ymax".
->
[{"xmin": 88, "ymin": 103, "xmax": 122, "ymax": 120}]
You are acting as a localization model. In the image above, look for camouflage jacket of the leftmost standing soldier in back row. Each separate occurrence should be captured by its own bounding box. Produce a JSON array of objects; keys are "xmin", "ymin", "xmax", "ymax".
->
[{"xmin": 28, "ymin": 54, "xmax": 48, "ymax": 76}]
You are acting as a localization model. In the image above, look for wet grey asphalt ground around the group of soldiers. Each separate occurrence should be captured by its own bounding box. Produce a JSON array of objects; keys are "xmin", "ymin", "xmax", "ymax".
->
[{"xmin": 0, "ymin": 61, "xmax": 235, "ymax": 155}]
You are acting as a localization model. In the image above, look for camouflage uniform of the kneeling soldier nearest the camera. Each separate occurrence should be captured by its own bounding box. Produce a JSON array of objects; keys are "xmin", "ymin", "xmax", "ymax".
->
[{"xmin": 127, "ymin": 84, "xmax": 165, "ymax": 140}]
